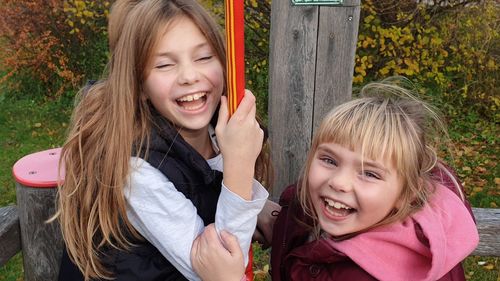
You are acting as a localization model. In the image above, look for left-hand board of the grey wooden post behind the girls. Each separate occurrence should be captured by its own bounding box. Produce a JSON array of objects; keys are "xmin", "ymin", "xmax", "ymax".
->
[{"xmin": 269, "ymin": 1, "xmax": 319, "ymax": 197}]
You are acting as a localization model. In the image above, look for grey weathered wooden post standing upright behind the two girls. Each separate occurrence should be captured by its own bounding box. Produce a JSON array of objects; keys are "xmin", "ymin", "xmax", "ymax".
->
[{"xmin": 269, "ymin": 0, "xmax": 360, "ymax": 200}]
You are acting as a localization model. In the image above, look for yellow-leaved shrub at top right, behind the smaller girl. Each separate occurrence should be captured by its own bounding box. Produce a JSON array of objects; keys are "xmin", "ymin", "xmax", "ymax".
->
[{"xmin": 354, "ymin": 0, "xmax": 500, "ymax": 115}]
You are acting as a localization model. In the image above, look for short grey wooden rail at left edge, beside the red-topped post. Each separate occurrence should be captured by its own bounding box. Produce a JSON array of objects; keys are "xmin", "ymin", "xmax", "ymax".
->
[{"xmin": 0, "ymin": 206, "xmax": 21, "ymax": 266}]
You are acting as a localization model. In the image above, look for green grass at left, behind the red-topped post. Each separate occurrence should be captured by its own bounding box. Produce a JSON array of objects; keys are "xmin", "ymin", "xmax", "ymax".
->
[{"xmin": 0, "ymin": 94, "xmax": 72, "ymax": 281}]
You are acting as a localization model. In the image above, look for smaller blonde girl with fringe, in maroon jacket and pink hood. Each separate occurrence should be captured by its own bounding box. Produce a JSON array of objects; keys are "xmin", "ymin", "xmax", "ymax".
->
[{"xmin": 271, "ymin": 80, "xmax": 478, "ymax": 280}]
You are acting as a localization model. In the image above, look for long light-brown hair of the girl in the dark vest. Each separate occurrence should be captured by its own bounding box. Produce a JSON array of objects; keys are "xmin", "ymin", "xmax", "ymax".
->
[{"xmin": 55, "ymin": 0, "xmax": 272, "ymax": 280}]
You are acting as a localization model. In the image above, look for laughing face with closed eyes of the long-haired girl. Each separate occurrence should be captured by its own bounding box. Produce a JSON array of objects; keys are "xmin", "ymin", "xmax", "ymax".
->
[{"xmin": 144, "ymin": 17, "xmax": 224, "ymax": 134}]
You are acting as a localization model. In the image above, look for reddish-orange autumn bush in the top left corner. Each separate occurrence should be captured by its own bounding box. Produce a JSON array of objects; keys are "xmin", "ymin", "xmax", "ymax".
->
[{"xmin": 0, "ymin": 0, "xmax": 109, "ymax": 96}]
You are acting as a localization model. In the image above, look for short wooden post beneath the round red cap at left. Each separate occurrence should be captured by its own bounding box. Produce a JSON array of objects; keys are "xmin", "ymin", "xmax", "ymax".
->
[{"xmin": 16, "ymin": 183, "xmax": 63, "ymax": 281}]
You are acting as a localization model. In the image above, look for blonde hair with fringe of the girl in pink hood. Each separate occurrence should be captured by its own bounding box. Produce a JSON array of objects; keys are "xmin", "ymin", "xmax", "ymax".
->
[{"xmin": 298, "ymin": 79, "xmax": 452, "ymax": 239}]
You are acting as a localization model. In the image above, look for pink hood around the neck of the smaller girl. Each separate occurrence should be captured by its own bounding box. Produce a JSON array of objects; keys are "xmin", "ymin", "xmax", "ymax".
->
[{"xmin": 331, "ymin": 185, "xmax": 479, "ymax": 281}]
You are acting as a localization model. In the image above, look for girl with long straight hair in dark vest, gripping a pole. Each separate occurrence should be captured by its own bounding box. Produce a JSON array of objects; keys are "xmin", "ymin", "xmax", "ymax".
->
[{"xmin": 58, "ymin": 0, "xmax": 269, "ymax": 281}]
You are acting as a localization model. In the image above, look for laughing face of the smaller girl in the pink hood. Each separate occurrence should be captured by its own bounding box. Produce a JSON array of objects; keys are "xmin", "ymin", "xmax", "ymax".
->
[{"xmin": 308, "ymin": 143, "xmax": 403, "ymax": 236}]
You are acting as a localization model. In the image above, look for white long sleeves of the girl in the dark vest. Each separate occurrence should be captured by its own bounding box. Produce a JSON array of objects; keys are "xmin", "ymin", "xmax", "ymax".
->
[{"xmin": 125, "ymin": 157, "xmax": 267, "ymax": 280}]
